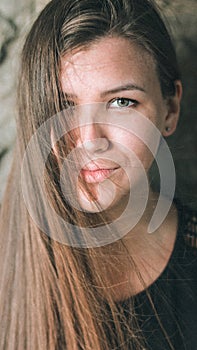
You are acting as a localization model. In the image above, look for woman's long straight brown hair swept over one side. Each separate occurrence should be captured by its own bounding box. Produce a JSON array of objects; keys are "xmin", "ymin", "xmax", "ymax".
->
[{"xmin": 0, "ymin": 0, "xmax": 180, "ymax": 350}]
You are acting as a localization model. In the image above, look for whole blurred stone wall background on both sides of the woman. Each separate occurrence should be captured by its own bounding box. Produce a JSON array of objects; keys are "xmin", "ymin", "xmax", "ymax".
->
[{"xmin": 0, "ymin": 0, "xmax": 197, "ymax": 207}]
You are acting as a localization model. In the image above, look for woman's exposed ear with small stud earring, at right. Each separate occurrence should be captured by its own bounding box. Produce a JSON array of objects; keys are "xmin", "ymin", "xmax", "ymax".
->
[{"xmin": 162, "ymin": 80, "xmax": 182, "ymax": 137}]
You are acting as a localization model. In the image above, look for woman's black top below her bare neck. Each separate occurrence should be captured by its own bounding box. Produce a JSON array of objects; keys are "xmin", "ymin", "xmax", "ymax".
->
[{"xmin": 115, "ymin": 207, "xmax": 197, "ymax": 350}]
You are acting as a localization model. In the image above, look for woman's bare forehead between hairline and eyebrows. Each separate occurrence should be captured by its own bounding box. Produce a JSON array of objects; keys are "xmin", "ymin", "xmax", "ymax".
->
[{"xmin": 61, "ymin": 37, "xmax": 157, "ymax": 95}]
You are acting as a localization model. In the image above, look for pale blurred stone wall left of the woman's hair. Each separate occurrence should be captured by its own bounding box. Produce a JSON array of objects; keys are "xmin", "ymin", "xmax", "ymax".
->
[{"xmin": 0, "ymin": 0, "xmax": 48, "ymax": 203}]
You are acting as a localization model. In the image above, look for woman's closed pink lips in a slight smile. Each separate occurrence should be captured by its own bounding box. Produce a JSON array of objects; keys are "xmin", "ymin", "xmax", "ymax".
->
[{"xmin": 80, "ymin": 167, "xmax": 119, "ymax": 183}]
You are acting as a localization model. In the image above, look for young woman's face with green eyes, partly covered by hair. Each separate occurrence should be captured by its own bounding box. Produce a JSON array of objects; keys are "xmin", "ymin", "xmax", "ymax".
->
[{"xmin": 58, "ymin": 38, "xmax": 171, "ymax": 212}]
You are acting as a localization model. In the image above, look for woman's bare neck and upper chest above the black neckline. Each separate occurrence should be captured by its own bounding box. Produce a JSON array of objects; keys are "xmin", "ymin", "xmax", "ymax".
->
[{"xmin": 91, "ymin": 193, "xmax": 177, "ymax": 300}]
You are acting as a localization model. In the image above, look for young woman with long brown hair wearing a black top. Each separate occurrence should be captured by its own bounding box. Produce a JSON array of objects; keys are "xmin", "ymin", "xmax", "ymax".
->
[{"xmin": 0, "ymin": 0, "xmax": 197, "ymax": 350}]
